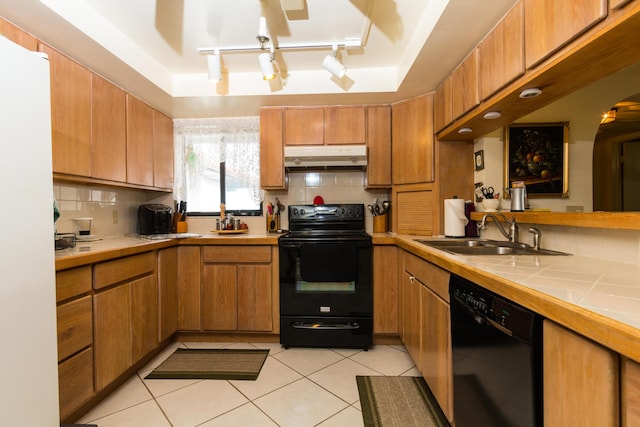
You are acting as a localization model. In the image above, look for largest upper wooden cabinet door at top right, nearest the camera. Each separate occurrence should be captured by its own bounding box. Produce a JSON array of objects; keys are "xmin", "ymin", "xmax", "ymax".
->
[{"xmin": 522, "ymin": 0, "xmax": 607, "ymax": 69}]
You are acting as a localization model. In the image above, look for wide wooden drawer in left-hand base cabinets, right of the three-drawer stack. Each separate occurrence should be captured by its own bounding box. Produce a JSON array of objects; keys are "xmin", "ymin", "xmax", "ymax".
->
[{"xmin": 93, "ymin": 252, "xmax": 156, "ymax": 289}]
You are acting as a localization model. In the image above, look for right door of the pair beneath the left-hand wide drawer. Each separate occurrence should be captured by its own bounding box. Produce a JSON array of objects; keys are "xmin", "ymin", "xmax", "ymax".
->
[{"xmin": 129, "ymin": 274, "xmax": 158, "ymax": 363}]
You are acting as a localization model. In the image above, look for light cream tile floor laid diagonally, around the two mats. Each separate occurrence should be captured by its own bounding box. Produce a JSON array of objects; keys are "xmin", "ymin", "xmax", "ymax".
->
[{"xmin": 77, "ymin": 342, "xmax": 420, "ymax": 427}]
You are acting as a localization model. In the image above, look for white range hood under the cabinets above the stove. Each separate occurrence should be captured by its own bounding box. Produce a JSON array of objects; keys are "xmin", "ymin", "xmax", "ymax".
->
[{"xmin": 284, "ymin": 145, "xmax": 367, "ymax": 168}]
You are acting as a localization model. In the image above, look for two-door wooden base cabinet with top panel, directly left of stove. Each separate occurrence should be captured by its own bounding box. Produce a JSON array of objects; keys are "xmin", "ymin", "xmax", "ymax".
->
[{"xmin": 202, "ymin": 246, "xmax": 273, "ymax": 332}]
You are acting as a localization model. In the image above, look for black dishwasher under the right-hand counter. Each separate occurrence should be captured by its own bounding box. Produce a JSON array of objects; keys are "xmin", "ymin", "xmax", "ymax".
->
[{"xmin": 449, "ymin": 275, "xmax": 543, "ymax": 427}]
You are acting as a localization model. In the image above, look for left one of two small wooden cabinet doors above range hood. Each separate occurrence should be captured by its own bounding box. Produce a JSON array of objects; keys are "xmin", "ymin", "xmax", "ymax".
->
[{"xmin": 284, "ymin": 108, "xmax": 324, "ymax": 145}]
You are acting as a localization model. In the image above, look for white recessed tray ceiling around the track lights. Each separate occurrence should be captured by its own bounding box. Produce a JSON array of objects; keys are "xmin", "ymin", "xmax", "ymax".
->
[{"xmin": 0, "ymin": 0, "xmax": 516, "ymax": 118}]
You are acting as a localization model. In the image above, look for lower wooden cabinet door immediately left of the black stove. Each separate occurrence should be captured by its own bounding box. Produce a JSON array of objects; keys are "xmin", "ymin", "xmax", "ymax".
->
[{"xmin": 238, "ymin": 265, "xmax": 273, "ymax": 331}]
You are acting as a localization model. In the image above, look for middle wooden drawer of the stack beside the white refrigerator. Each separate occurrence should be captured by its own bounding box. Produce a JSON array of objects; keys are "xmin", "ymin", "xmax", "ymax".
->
[{"xmin": 57, "ymin": 295, "xmax": 93, "ymax": 360}]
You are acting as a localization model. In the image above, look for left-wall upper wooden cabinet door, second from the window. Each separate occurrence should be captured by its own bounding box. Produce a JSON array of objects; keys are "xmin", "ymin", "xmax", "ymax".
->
[{"xmin": 127, "ymin": 94, "xmax": 153, "ymax": 187}]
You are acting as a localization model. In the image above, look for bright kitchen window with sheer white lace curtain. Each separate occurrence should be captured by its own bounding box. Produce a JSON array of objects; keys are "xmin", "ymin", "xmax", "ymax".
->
[{"xmin": 174, "ymin": 117, "xmax": 263, "ymax": 216}]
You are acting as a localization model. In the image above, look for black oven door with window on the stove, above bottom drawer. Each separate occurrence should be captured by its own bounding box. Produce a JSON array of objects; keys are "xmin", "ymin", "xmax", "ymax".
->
[{"xmin": 279, "ymin": 237, "xmax": 373, "ymax": 317}]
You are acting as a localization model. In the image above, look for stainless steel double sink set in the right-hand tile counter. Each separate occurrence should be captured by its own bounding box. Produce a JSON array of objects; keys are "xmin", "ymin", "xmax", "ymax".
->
[{"xmin": 416, "ymin": 238, "xmax": 571, "ymax": 255}]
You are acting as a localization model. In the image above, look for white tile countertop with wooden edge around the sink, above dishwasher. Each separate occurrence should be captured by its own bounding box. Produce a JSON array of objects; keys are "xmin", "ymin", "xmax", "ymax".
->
[{"xmin": 392, "ymin": 235, "xmax": 640, "ymax": 362}]
